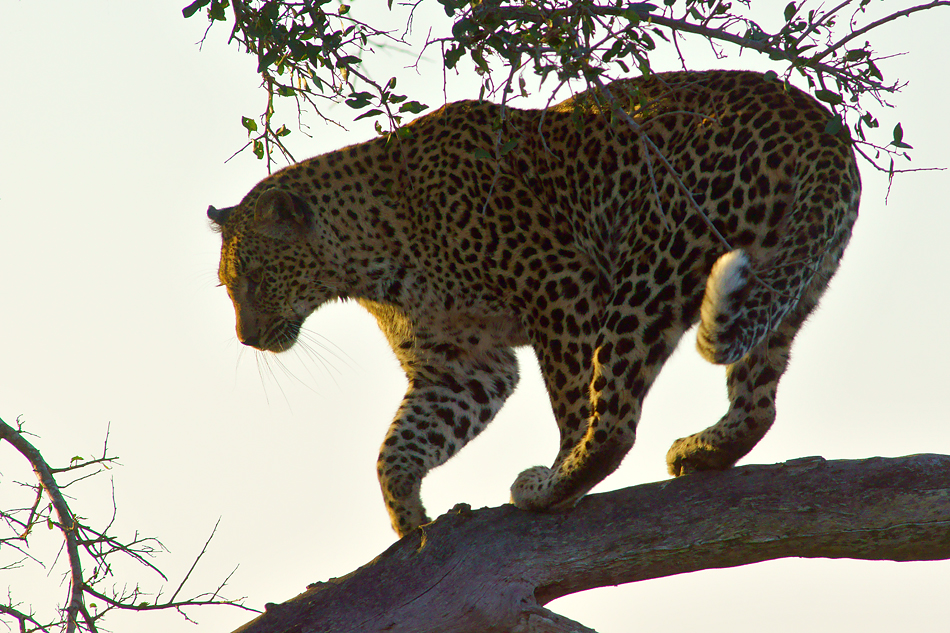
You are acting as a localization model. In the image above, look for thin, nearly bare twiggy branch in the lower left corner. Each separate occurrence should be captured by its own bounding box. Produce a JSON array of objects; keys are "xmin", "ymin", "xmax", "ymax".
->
[{"xmin": 0, "ymin": 419, "xmax": 254, "ymax": 633}]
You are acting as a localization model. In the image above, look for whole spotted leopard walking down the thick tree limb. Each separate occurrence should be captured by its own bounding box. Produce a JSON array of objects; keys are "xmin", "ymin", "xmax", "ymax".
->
[{"xmin": 207, "ymin": 70, "xmax": 861, "ymax": 537}]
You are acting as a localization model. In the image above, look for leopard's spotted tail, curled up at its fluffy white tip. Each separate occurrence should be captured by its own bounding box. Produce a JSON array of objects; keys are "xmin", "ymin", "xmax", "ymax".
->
[{"xmin": 696, "ymin": 105, "xmax": 861, "ymax": 365}]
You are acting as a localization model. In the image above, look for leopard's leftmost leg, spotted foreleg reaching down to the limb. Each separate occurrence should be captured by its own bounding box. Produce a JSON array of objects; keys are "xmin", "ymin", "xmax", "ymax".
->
[{"xmin": 377, "ymin": 342, "xmax": 518, "ymax": 536}]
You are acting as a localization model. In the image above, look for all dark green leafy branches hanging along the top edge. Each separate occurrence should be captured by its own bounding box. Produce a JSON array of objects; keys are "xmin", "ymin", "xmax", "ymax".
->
[{"xmin": 182, "ymin": 0, "xmax": 950, "ymax": 173}]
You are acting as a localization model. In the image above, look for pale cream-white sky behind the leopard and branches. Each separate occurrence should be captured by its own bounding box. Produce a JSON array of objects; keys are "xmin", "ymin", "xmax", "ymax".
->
[{"xmin": 0, "ymin": 0, "xmax": 950, "ymax": 633}]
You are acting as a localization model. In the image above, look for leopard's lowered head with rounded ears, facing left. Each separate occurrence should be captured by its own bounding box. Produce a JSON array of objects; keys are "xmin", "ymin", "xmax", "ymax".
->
[{"xmin": 208, "ymin": 187, "xmax": 338, "ymax": 352}]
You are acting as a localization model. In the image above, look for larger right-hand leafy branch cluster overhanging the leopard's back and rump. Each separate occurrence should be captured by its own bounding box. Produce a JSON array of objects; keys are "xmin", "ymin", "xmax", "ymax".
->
[{"xmin": 439, "ymin": 0, "xmax": 950, "ymax": 175}]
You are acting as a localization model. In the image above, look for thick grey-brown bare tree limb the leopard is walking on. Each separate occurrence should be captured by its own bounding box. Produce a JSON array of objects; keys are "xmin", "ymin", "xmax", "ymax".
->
[{"xmin": 236, "ymin": 455, "xmax": 950, "ymax": 633}]
